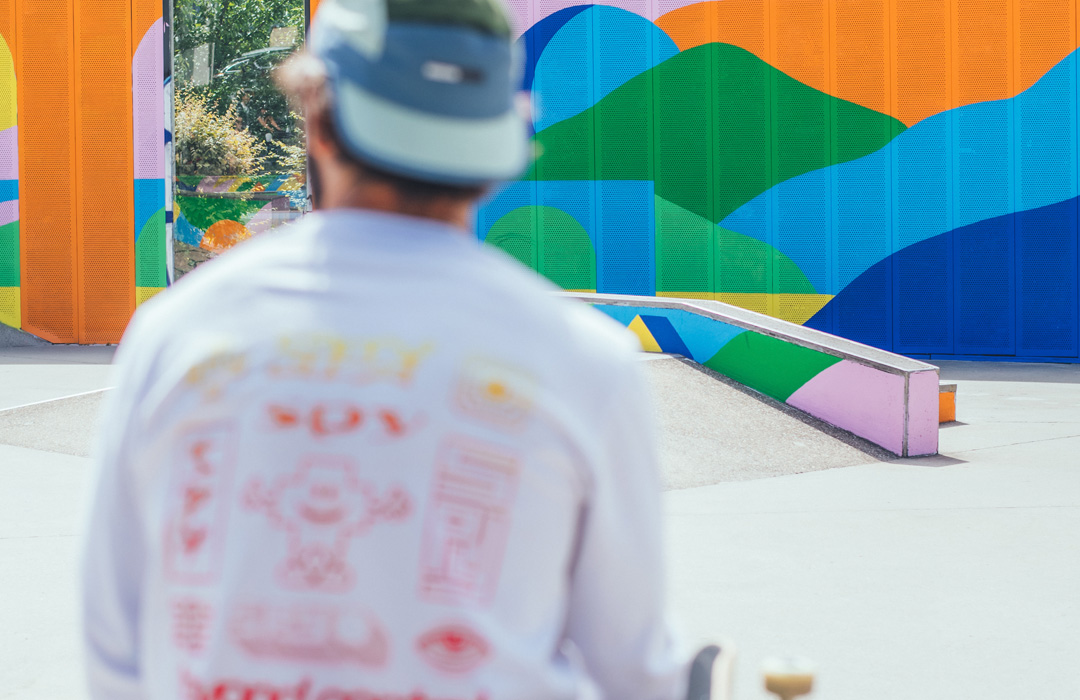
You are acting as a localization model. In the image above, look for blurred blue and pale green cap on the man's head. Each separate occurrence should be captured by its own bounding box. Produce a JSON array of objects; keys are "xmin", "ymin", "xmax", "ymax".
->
[{"xmin": 309, "ymin": 0, "xmax": 530, "ymax": 187}]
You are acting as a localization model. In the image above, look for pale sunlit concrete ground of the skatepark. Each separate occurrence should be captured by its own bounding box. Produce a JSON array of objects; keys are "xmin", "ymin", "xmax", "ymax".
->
[{"xmin": 0, "ymin": 348, "xmax": 1080, "ymax": 700}]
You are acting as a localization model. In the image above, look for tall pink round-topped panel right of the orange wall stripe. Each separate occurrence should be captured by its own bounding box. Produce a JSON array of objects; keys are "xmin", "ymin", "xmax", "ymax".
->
[{"xmin": 132, "ymin": 19, "xmax": 165, "ymax": 179}]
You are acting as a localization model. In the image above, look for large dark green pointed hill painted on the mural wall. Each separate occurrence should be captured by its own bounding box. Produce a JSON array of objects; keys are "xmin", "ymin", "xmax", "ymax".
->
[{"xmin": 526, "ymin": 43, "xmax": 906, "ymax": 224}]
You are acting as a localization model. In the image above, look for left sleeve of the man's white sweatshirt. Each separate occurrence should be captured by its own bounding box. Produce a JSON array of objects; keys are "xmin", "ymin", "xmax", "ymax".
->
[{"xmin": 81, "ymin": 321, "xmax": 154, "ymax": 700}]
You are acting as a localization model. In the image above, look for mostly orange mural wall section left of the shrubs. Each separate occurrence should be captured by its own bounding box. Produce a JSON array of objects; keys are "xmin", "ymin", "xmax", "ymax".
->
[{"xmin": 0, "ymin": 0, "xmax": 167, "ymax": 344}]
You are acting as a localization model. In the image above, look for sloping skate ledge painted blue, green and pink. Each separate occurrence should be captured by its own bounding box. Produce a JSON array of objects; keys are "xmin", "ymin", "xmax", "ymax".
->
[{"xmin": 561, "ymin": 292, "xmax": 940, "ymax": 457}]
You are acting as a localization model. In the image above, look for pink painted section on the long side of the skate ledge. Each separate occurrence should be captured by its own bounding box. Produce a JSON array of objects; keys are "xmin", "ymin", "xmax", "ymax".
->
[{"xmin": 787, "ymin": 360, "xmax": 904, "ymax": 455}]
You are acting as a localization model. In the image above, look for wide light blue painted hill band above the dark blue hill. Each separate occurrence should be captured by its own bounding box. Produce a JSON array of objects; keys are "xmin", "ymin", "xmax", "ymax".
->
[{"xmin": 719, "ymin": 47, "xmax": 1077, "ymax": 294}]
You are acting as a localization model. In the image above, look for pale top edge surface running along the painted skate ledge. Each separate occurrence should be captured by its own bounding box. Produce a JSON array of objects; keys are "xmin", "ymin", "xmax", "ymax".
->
[{"xmin": 559, "ymin": 292, "xmax": 939, "ymax": 375}]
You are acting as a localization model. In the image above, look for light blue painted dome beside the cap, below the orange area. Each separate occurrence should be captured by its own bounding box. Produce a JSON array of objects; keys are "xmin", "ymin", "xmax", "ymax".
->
[{"xmin": 532, "ymin": 5, "xmax": 678, "ymax": 132}]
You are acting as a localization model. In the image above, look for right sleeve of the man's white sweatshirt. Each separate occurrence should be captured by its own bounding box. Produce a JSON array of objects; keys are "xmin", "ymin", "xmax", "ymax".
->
[{"xmin": 567, "ymin": 360, "xmax": 687, "ymax": 700}]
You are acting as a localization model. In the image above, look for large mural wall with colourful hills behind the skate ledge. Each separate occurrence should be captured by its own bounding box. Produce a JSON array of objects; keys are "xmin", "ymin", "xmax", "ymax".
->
[{"xmin": 477, "ymin": 0, "xmax": 1080, "ymax": 361}]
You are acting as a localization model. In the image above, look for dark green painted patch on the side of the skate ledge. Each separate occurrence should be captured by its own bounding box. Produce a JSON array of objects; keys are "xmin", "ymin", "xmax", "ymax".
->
[{"xmin": 705, "ymin": 331, "xmax": 840, "ymax": 401}]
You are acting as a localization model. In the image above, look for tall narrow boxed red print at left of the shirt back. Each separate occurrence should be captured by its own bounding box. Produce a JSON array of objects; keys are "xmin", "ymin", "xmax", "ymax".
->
[{"xmin": 164, "ymin": 422, "xmax": 237, "ymax": 585}]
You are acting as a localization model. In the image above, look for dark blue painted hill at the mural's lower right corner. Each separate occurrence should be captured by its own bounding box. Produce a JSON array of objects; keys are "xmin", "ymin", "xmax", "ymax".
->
[{"xmin": 806, "ymin": 198, "xmax": 1080, "ymax": 360}]
